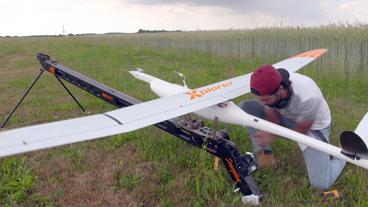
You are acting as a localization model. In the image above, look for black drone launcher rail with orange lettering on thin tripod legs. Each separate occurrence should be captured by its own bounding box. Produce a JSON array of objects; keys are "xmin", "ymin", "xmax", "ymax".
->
[{"xmin": 37, "ymin": 53, "xmax": 262, "ymax": 199}]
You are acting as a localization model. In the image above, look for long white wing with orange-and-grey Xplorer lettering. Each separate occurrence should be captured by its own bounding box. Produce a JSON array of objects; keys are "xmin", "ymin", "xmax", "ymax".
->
[{"xmin": 0, "ymin": 74, "xmax": 249, "ymax": 157}]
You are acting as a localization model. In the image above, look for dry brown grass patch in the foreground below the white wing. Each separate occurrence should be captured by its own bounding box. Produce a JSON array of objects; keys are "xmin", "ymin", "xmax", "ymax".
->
[{"xmin": 30, "ymin": 143, "xmax": 164, "ymax": 206}]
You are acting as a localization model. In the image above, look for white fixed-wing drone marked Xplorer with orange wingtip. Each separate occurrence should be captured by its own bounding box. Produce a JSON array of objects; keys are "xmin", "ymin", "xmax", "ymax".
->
[{"xmin": 0, "ymin": 49, "xmax": 368, "ymax": 205}]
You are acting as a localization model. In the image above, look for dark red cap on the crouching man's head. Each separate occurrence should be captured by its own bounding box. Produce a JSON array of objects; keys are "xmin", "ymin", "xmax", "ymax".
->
[{"xmin": 250, "ymin": 65, "xmax": 282, "ymax": 96}]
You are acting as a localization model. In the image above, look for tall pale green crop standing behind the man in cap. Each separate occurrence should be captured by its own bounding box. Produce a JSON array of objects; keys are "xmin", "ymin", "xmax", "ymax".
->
[{"xmin": 121, "ymin": 23, "xmax": 368, "ymax": 73}]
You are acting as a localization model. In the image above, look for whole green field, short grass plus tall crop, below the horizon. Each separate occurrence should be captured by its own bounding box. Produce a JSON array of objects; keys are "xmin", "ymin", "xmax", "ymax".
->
[{"xmin": 0, "ymin": 25, "xmax": 368, "ymax": 207}]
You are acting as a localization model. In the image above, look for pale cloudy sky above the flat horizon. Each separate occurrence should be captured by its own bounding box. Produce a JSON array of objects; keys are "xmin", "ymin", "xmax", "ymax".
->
[{"xmin": 0, "ymin": 0, "xmax": 368, "ymax": 36}]
